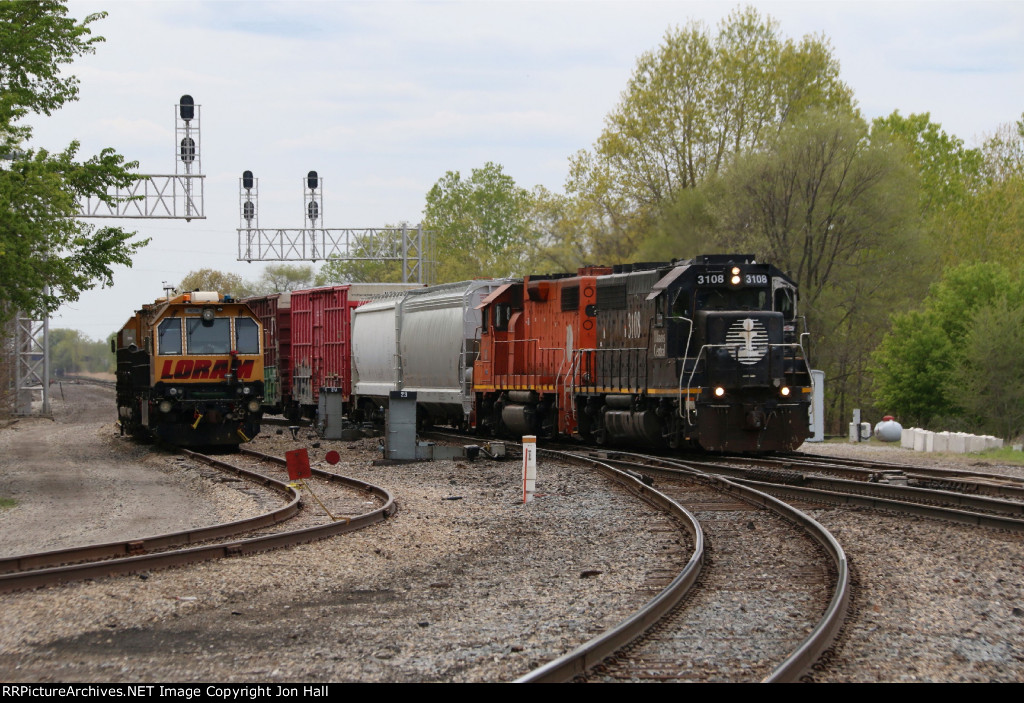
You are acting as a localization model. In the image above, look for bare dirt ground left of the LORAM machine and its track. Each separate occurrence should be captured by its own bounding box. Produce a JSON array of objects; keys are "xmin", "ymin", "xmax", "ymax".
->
[{"xmin": 0, "ymin": 382, "xmax": 247, "ymax": 556}]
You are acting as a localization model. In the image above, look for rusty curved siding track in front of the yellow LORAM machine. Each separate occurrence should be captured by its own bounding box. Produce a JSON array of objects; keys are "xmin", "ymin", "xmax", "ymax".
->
[{"xmin": 0, "ymin": 450, "xmax": 396, "ymax": 592}]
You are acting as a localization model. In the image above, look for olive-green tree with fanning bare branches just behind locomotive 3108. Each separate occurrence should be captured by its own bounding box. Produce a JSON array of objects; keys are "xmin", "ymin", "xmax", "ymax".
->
[{"xmin": 700, "ymin": 111, "xmax": 928, "ymax": 427}]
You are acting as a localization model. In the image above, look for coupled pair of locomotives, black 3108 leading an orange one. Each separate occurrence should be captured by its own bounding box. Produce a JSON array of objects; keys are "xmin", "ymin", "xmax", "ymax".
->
[{"xmin": 473, "ymin": 255, "xmax": 811, "ymax": 451}]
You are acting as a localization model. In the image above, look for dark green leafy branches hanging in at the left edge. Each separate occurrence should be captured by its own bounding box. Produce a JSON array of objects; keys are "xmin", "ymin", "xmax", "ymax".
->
[{"xmin": 0, "ymin": 0, "xmax": 146, "ymax": 321}]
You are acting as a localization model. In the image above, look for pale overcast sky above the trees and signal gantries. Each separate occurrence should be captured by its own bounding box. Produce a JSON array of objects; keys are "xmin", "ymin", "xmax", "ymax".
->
[{"xmin": 25, "ymin": 0, "xmax": 1024, "ymax": 339}]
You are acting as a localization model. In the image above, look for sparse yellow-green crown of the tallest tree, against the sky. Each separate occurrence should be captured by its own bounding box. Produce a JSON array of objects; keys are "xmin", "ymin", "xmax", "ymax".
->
[{"xmin": 566, "ymin": 7, "xmax": 853, "ymax": 260}]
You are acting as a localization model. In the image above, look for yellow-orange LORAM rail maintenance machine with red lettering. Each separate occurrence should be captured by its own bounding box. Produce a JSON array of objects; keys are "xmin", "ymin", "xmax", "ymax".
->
[{"xmin": 111, "ymin": 292, "xmax": 263, "ymax": 446}]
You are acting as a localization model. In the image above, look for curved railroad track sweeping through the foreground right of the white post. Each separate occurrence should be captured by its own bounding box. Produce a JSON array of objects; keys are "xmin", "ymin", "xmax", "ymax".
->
[{"xmin": 519, "ymin": 452, "xmax": 850, "ymax": 683}]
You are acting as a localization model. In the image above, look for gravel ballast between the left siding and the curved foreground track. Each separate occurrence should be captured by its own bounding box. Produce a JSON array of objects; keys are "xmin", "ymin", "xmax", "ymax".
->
[{"xmin": 0, "ymin": 384, "xmax": 681, "ymax": 682}]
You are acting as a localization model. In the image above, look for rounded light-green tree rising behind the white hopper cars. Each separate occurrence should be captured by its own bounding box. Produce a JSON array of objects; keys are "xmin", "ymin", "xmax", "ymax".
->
[{"xmin": 424, "ymin": 162, "xmax": 535, "ymax": 282}]
